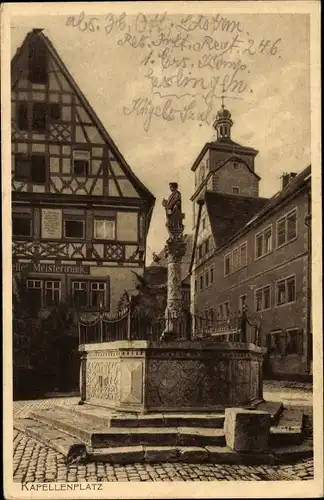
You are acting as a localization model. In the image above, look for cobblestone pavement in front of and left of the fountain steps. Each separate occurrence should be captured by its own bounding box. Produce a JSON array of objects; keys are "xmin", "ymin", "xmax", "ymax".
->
[{"xmin": 13, "ymin": 398, "xmax": 314, "ymax": 482}]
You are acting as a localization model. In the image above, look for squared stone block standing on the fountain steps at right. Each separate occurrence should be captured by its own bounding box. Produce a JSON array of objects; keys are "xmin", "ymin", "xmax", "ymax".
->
[{"xmin": 224, "ymin": 408, "xmax": 271, "ymax": 452}]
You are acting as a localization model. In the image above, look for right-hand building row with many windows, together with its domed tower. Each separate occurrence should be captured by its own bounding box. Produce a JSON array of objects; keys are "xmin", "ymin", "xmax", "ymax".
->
[{"xmin": 190, "ymin": 107, "xmax": 312, "ymax": 375}]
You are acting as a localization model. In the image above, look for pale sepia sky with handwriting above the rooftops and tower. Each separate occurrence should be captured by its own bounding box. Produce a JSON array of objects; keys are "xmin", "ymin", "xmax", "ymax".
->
[{"xmin": 11, "ymin": 4, "xmax": 310, "ymax": 262}]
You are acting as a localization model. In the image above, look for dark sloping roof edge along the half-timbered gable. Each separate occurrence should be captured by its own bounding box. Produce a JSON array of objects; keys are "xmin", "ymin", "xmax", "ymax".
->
[{"xmin": 11, "ymin": 29, "xmax": 155, "ymax": 208}]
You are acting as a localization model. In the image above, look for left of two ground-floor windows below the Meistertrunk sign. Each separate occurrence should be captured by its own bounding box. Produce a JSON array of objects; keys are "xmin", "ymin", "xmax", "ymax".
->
[{"xmin": 26, "ymin": 279, "xmax": 61, "ymax": 308}]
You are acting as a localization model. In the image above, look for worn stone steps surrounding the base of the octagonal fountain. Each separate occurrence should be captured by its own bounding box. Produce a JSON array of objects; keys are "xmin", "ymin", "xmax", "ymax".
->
[{"xmin": 14, "ymin": 403, "xmax": 312, "ymax": 464}]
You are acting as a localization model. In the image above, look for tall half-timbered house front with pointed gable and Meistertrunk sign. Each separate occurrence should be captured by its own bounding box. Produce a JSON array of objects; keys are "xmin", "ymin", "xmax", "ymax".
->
[{"xmin": 11, "ymin": 30, "xmax": 155, "ymax": 312}]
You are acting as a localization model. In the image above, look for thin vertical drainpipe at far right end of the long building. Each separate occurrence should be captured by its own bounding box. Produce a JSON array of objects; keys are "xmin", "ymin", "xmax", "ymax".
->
[{"xmin": 305, "ymin": 190, "xmax": 313, "ymax": 373}]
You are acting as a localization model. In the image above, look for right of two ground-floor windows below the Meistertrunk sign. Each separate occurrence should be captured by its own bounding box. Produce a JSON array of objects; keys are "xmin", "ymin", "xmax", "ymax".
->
[{"xmin": 72, "ymin": 281, "xmax": 108, "ymax": 309}]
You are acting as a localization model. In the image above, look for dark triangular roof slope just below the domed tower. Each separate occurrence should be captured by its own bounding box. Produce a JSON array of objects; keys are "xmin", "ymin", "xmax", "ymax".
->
[{"xmin": 205, "ymin": 191, "xmax": 268, "ymax": 247}]
